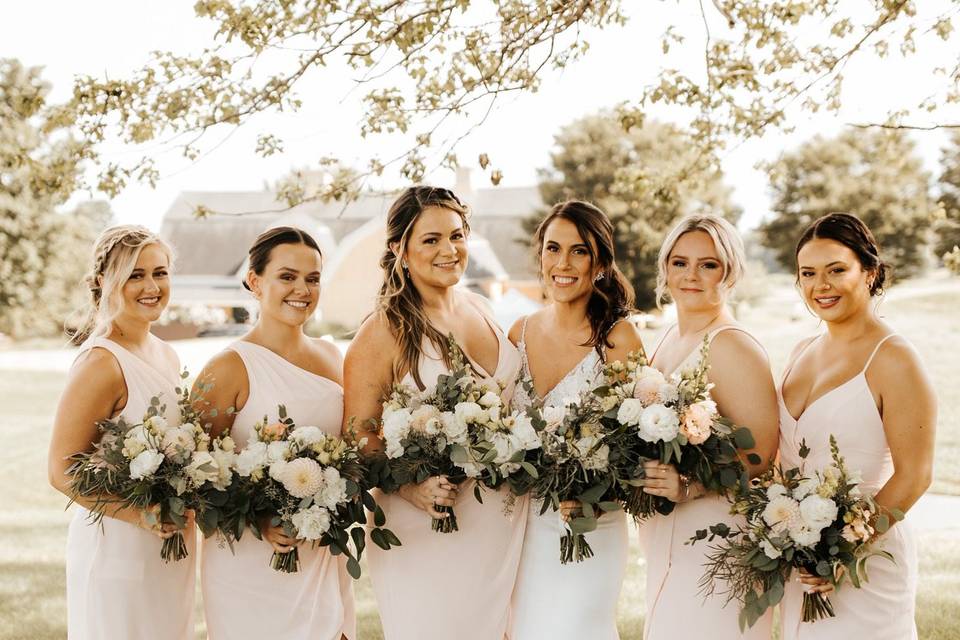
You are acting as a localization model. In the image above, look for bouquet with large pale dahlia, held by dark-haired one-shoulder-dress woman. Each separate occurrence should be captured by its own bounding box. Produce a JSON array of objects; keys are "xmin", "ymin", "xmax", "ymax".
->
[{"xmin": 222, "ymin": 405, "xmax": 399, "ymax": 578}]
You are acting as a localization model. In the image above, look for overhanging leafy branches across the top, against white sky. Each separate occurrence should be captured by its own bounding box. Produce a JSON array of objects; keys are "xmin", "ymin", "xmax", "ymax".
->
[{"xmin": 63, "ymin": 0, "xmax": 960, "ymax": 218}]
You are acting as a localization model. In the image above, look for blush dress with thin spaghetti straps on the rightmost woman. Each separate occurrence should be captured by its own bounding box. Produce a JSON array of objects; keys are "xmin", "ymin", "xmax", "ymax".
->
[{"xmin": 779, "ymin": 334, "xmax": 917, "ymax": 640}]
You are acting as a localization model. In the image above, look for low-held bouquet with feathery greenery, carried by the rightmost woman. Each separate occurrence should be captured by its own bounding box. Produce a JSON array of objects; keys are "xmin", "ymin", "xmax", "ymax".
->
[{"xmin": 690, "ymin": 436, "xmax": 903, "ymax": 629}]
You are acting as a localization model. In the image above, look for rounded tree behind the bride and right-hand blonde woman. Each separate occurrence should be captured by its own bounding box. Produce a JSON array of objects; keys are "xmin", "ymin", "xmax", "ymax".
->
[{"xmin": 526, "ymin": 111, "xmax": 740, "ymax": 309}]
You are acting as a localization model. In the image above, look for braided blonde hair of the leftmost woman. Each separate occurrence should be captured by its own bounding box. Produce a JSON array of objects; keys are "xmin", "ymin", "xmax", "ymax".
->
[{"xmin": 65, "ymin": 225, "xmax": 173, "ymax": 344}]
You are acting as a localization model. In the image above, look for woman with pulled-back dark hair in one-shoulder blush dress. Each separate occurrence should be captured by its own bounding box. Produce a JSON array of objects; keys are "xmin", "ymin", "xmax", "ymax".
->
[{"xmin": 197, "ymin": 227, "xmax": 356, "ymax": 640}]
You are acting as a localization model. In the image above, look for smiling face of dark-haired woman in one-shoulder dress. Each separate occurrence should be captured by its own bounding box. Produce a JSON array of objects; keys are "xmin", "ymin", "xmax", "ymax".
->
[{"xmin": 247, "ymin": 243, "xmax": 322, "ymax": 326}]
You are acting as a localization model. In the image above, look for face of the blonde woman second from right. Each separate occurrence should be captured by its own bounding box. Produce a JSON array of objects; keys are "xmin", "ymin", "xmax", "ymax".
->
[{"xmin": 667, "ymin": 231, "xmax": 726, "ymax": 312}]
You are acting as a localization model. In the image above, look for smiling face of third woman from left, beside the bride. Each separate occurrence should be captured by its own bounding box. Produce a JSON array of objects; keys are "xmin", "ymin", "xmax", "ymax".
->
[{"xmin": 402, "ymin": 207, "xmax": 468, "ymax": 288}]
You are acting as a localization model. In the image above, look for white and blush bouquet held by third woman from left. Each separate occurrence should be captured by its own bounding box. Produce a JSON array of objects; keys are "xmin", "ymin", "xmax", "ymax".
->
[{"xmin": 380, "ymin": 337, "xmax": 539, "ymax": 533}]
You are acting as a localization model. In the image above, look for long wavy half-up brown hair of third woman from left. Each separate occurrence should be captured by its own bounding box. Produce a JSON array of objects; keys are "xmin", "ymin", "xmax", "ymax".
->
[{"xmin": 377, "ymin": 186, "xmax": 470, "ymax": 389}]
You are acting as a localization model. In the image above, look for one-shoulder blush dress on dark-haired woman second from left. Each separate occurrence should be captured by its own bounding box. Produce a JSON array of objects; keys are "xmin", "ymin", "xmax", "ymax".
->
[{"xmin": 200, "ymin": 340, "xmax": 356, "ymax": 640}]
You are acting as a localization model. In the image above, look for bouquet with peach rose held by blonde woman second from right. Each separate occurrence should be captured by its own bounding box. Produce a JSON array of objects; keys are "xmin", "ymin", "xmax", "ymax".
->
[{"xmin": 608, "ymin": 341, "xmax": 760, "ymax": 519}]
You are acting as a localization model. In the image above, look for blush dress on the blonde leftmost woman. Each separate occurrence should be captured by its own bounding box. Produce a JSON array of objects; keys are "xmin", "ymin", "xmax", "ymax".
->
[{"xmin": 67, "ymin": 338, "xmax": 197, "ymax": 640}]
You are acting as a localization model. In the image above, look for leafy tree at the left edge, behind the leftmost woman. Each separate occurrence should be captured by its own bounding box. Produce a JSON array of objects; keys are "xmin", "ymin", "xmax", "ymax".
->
[{"xmin": 0, "ymin": 60, "xmax": 109, "ymax": 336}]
